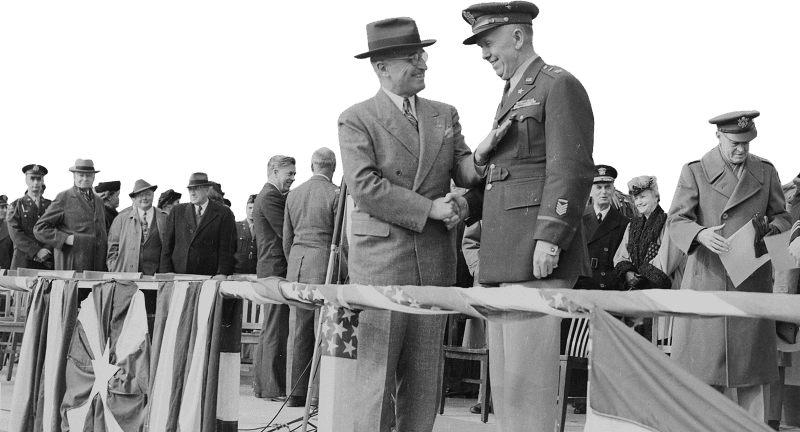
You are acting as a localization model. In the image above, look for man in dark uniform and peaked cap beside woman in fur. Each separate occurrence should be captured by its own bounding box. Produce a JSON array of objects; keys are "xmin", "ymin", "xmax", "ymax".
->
[{"xmin": 576, "ymin": 164, "xmax": 631, "ymax": 290}]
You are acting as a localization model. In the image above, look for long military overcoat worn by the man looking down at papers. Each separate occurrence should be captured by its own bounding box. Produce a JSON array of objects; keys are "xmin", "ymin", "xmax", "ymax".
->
[{"xmin": 667, "ymin": 147, "xmax": 790, "ymax": 387}]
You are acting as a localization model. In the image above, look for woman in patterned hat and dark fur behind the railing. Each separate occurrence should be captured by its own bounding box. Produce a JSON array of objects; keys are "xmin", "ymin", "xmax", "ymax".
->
[{"xmin": 614, "ymin": 175, "xmax": 685, "ymax": 339}]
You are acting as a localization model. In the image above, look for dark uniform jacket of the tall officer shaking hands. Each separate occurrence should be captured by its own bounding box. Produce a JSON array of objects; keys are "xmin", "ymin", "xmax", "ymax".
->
[{"xmin": 466, "ymin": 57, "xmax": 594, "ymax": 288}]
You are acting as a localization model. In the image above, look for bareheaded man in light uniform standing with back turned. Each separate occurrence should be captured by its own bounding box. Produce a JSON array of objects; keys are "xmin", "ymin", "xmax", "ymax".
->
[{"xmin": 283, "ymin": 147, "xmax": 339, "ymax": 406}]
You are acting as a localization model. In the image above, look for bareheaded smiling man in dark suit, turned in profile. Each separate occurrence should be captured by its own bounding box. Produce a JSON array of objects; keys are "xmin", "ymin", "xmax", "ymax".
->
[{"xmin": 253, "ymin": 155, "xmax": 297, "ymax": 401}]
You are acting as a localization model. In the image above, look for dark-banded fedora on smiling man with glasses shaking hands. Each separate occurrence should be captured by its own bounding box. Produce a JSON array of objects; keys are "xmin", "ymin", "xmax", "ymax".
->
[{"xmin": 353, "ymin": 17, "xmax": 436, "ymax": 59}]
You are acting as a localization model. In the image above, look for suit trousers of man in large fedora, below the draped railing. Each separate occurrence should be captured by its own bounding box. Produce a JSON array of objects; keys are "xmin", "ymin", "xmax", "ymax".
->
[{"xmin": 352, "ymin": 310, "xmax": 445, "ymax": 432}]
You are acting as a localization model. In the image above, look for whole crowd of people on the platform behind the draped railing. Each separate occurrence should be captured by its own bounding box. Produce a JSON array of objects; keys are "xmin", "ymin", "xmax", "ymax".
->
[{"xmin": 0, "ymin": 1, "xmax": 800, "ymax": 432}]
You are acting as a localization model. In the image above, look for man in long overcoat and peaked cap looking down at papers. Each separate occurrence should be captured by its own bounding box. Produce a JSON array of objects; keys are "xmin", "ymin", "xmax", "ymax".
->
[{"xmin": 667, "ymin": 111, "xmax": 791, "ymax": 419}]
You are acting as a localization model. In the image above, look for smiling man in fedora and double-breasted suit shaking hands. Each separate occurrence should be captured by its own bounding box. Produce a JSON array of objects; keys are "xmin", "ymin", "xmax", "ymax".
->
[{"xmin": 337, "ymin": 17, "xmax": 505, "ymax": 432}]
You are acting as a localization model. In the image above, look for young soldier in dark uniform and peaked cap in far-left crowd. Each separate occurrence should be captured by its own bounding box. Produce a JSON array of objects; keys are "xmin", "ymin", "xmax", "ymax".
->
[{"xmin": 8, "ymin": 164, "xmax": 53, "ymax": 270}]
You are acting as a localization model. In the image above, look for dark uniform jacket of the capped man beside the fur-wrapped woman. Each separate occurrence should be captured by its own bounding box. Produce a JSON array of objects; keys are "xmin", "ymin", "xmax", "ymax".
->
[{"xmin": 575, "ymin": 205, "xmax": 630, "ymax": 290}]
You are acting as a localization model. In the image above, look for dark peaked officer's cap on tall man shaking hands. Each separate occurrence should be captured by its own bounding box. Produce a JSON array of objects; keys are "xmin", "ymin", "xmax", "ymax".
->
[{"xmin": 461, "ymin": 0, "xmax": 539, "ymax": 45}]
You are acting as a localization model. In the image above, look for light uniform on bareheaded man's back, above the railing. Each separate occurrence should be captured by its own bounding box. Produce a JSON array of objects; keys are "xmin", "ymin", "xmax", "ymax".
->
[{"xmin": 283, "ymin": 175, "xmax": 339, "ymax": 283}]
